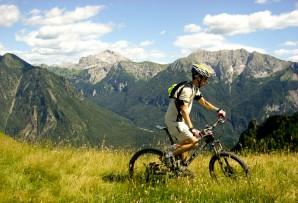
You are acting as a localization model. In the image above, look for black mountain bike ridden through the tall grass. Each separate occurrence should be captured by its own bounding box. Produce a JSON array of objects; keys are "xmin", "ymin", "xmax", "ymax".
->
[{"xmin": 129, "ymin": 118, "xmax": 249, "ymax": 181}]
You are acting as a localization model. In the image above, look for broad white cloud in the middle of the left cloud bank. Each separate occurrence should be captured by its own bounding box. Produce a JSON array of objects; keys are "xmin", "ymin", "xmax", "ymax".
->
[{"xmin": 16, "ymin": 22, "xmax": 112, "ymax": 54}]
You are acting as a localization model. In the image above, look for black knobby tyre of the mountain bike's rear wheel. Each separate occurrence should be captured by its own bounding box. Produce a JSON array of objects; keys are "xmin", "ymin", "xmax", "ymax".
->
[{"xmin": 129, "ymin": 148, "xmax": 164, "ymax": 178}]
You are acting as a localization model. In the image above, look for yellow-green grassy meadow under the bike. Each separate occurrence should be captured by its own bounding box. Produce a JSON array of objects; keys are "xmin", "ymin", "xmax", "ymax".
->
[{"xmin": 0, "ymin": 131, "xmax": 298, "ymax": 202}]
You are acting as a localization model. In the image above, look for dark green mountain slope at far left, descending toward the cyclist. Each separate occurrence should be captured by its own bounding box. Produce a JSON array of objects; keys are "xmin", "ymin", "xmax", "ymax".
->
[{"xmin": 0, "ymin": 54, "xmax": 152, "ymax": 146}]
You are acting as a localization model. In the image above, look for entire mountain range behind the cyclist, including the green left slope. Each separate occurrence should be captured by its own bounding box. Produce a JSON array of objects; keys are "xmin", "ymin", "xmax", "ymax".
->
[{"xmin": 0, "ymin": 49, "xmax": 298, "ymax": 146}]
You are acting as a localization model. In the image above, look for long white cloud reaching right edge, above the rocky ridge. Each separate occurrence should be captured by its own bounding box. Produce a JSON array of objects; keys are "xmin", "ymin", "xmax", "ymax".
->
[{"xmin": 203, "ymin": 10, "xmax": 298, "ymax": 35}]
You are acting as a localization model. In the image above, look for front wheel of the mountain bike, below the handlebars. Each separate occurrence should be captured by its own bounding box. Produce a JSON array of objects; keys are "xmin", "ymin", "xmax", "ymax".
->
[{"xmin": 209, "ymin": 151, "xmax": 249, "ymax": 180}]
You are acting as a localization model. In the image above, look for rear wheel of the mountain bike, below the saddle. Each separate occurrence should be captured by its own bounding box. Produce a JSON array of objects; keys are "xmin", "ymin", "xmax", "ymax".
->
[{"xmin": 129, "ymin": 148, "xmax": 168, "ymax": 182}]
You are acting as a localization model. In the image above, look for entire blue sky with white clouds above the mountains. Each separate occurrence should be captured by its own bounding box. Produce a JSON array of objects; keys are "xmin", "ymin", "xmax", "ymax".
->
[{"xmin": 0, "ymin": 0, "xmax": 298, "ymax": 64}]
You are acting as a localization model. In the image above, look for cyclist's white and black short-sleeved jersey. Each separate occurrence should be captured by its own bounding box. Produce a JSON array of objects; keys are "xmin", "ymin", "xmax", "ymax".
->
[{"xmin": 165, "ymin": 83, "xmax": 201, "ymax": 123}]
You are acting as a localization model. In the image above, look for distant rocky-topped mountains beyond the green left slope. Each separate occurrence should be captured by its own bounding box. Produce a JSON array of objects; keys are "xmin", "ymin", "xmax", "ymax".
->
[{"xmin": 48, "ymin": 49, "xmax": 298, "ymax": 146}]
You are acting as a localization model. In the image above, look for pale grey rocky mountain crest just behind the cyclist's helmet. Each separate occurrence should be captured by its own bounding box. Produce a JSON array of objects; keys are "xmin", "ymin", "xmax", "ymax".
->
[{"xmin": 176, "ymin": 49, "xmax": 290, "ymax": 84}]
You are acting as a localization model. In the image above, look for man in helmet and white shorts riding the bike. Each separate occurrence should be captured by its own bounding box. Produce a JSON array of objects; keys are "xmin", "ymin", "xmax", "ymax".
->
[{"xmin": 165, "ymin": 64, "xmax": 226, "ymax": 170}]
